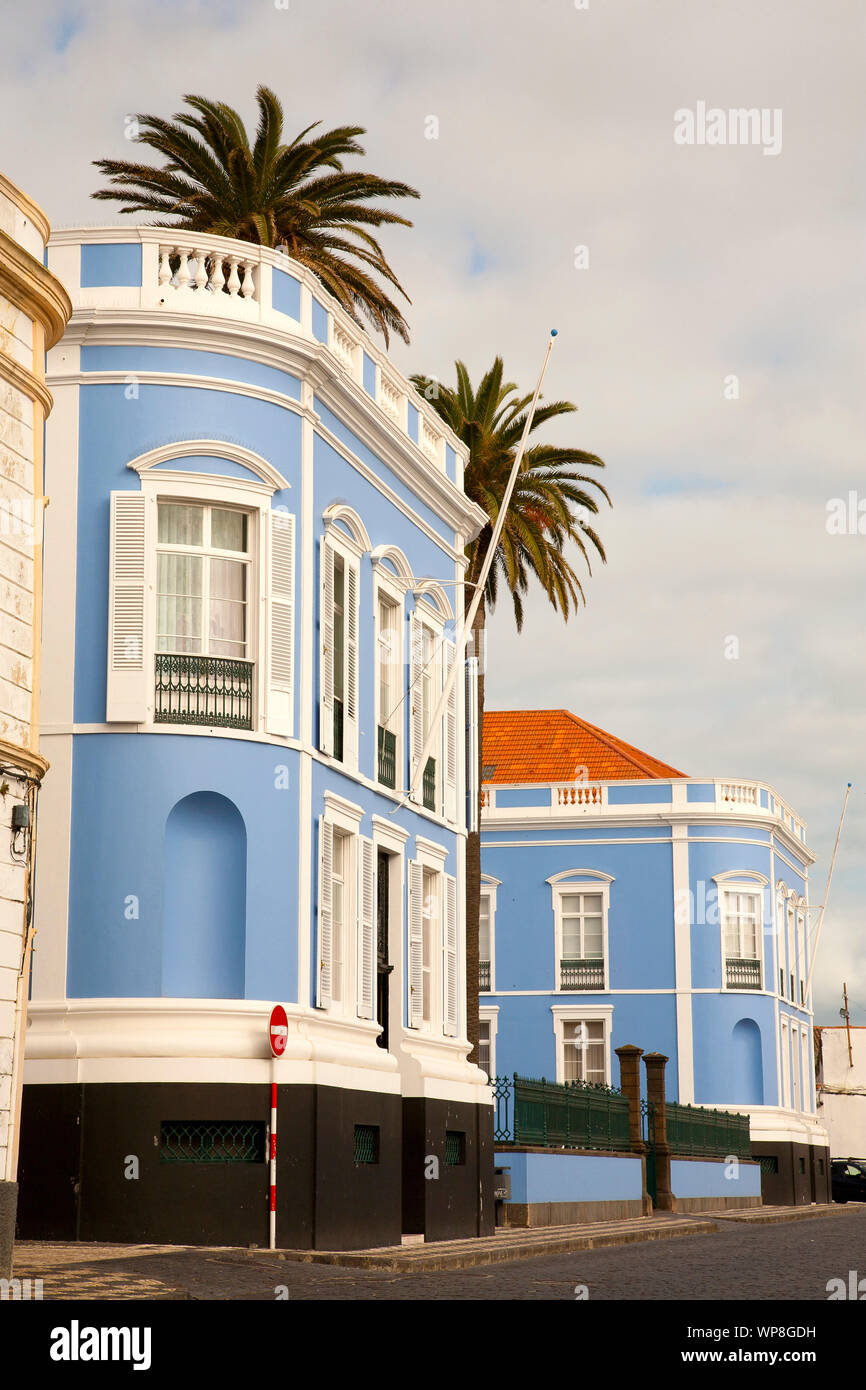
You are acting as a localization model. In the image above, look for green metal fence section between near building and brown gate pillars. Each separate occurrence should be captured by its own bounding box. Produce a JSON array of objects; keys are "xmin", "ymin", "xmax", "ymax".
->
[{"xmin": 491, "ymin": 1074, "xmax": 628, "ymax": 1152}]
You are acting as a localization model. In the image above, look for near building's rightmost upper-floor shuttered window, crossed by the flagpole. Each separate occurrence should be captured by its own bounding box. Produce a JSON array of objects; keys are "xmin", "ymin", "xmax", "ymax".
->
[{"xmin": 409, "ymin": 595, "xmax": 457, "ymax": 821}]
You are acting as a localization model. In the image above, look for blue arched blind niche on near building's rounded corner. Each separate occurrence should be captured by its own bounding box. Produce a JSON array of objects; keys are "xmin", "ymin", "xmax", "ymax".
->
[{"xmin": 163, "ymin": 791, "xmax": 246, "ymax": 999}]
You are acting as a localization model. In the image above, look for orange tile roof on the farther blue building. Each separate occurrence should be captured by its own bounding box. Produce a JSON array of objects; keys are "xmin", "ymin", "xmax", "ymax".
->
[{"xmin": 482, "ymin": 709, "xmax": 688, "ymax": 784}]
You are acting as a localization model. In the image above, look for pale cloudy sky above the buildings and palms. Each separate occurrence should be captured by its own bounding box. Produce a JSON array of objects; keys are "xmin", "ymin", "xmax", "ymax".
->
[{"xmin": 0, "ymin": 0, "xmax": 866, "ymax": 1023}]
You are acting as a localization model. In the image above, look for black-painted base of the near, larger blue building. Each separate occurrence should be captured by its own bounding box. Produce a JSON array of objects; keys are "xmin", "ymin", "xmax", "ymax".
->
[{"xmin": 17, "ymin": 1083, "xmax": 493, "ymax": 1250}]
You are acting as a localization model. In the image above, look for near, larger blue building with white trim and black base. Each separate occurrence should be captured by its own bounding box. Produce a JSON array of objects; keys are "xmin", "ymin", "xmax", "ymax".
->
[{"xmin": 19, "ymin": 228, "xmax": 492, "ymax": 1248}]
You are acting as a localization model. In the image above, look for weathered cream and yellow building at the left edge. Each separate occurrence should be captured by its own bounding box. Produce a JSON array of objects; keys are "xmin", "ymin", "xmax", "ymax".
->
[{"xmin": 0, "ymin": 174, "xmax": 72, "ymax": 1277}]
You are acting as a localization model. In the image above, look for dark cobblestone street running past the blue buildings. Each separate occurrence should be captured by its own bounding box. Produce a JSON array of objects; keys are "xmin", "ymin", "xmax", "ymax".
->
[{"xmin": 15, "ymin": 1208, "xmax": 866, "ymax": 1301}]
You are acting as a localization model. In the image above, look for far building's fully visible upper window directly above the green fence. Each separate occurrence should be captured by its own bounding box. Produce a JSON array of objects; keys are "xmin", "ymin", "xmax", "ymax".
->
[{"xmin": 548, "ymin": 869, "xmax": 613, "ymax": 994}]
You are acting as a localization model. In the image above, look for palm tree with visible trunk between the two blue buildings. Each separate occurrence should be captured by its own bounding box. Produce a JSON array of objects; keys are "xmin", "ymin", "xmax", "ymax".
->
[{"xmin": 411, "ymin": 357, "xmax": 610, "ymax": 1061}]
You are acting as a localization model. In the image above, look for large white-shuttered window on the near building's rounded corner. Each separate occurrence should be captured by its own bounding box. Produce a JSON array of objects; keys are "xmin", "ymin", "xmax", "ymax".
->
[{"xmin": 106, "ymin": 464, "xmax": 295, "ymax": 737}]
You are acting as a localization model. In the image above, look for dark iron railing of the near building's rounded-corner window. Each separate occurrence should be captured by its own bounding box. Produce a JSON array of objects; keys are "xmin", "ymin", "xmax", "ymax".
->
[{"xmin": 153, "ymin": 652, "xmax": 254, "ymax": 728}]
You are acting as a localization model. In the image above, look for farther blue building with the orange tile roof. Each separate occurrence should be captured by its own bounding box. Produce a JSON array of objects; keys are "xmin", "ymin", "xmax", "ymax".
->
[{"xmin": 480, "ymin": 710, "xmax": 828, "ymax": 1202}]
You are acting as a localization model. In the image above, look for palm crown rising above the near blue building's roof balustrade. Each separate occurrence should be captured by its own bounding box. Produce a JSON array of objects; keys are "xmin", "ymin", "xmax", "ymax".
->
[{"xmin": 90, "ymin": 86, "xmax": 420, "ymax": 343}]
